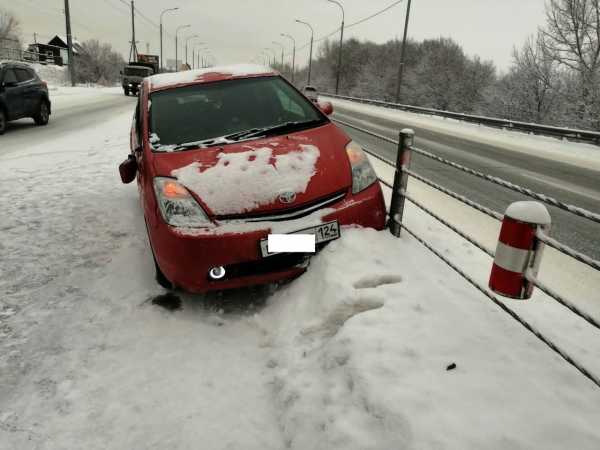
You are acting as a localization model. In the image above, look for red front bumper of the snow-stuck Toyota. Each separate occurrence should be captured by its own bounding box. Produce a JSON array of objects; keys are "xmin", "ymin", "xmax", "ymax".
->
[{"xmin": 148, "ymin": 183, "xmax": 386, "ymax": 293}]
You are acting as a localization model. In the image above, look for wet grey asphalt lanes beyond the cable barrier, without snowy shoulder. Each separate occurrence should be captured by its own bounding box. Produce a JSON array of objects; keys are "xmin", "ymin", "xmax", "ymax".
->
[{"xmin": 333, "ymin": 104, "xmax": 600, "ymax": 259}]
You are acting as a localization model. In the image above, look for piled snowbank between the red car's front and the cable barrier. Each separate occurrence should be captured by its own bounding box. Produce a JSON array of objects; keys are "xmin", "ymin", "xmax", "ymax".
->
[{"xmin": 257, "ymin": 229, "xmax": 600, "ymax": 450}]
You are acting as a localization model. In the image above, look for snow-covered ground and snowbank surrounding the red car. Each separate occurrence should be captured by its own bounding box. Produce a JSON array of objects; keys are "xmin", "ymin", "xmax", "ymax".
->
[{"xmin": 0, "ymin": 89, "xmax": 600, "ymax": 450}]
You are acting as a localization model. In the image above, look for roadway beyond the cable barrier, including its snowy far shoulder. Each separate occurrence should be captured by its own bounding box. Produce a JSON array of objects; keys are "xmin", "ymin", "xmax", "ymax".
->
[{"xmin": 333, "ymin": 100, "xmax": 600, "ymax": 259}]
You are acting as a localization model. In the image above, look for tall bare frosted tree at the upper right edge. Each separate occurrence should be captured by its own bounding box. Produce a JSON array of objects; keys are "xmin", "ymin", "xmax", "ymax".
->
[{"xmin": 541, "ymin": 0, "xmax": 600, "ymax": 129}]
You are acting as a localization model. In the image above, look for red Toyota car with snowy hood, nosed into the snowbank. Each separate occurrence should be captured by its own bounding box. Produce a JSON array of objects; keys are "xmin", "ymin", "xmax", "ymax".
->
[{"xmin": 119, "ymin": 66, "xmax": 386, "ymax": 293}]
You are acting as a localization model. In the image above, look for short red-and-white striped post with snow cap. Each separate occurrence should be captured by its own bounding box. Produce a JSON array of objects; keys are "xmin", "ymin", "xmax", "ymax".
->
[{"xmin": 489, "ymin": 201, "xmax": 552, "ymax": 300}]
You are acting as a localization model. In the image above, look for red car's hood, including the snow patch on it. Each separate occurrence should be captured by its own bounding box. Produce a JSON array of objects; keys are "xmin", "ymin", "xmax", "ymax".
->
[{"xmin": 153, "ymin": 123, "xmax": 352, "ymax": 218}]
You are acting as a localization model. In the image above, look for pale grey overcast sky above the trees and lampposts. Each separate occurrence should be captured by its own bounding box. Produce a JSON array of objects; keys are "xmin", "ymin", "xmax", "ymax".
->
[{"xmin": 5, "ymin": 0, "xmax": 544, "ymax": 69}]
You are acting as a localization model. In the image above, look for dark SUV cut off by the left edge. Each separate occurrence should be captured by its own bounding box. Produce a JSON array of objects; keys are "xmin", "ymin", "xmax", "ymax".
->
[{"xmin": 0, "ymin": 61, "xmax": 50, "ymax": 134}]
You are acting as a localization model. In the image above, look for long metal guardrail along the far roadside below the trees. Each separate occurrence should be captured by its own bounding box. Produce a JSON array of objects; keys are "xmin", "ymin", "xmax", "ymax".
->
[{"xmin": 321, "ymin": 92, "xmax": 600, "ymax": 145}]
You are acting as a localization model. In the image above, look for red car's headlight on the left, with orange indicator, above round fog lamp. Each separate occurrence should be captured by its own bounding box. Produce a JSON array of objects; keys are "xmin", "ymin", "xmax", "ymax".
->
[{"xmin": 154, "ymin": 177, "xmax": 213, "ymax": 228}]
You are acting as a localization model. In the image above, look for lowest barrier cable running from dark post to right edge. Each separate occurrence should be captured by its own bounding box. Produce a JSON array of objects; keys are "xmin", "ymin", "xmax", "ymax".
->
[{"xmin": 402, "ymin": 224, "xmax": 600, "ymax": 387}]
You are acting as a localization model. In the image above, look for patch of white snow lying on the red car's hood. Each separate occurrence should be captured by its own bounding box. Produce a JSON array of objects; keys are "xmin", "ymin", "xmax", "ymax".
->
[{"xmin": 171, "ymin": 144, "xmax": 320, "ymax": 214}]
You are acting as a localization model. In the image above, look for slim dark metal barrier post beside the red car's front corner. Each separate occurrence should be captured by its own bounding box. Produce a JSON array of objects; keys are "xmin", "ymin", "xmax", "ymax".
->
[{"xmin": 388, "ymin": 128, "xmax": 415, "ymax": 237}]
